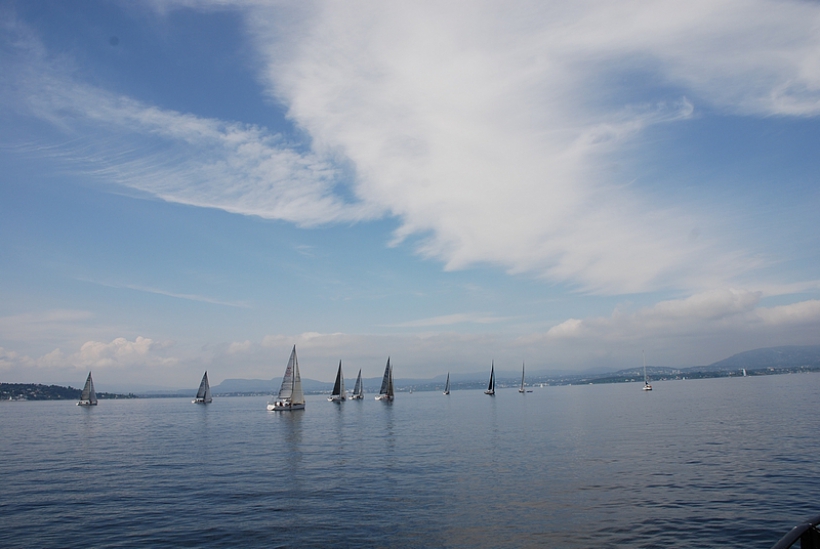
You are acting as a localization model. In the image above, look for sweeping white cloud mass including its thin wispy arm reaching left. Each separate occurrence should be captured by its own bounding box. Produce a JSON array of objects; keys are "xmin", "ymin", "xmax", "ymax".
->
[{"xmin": 4, "ymin": 0, "xmax": 820, "ymax": 294}]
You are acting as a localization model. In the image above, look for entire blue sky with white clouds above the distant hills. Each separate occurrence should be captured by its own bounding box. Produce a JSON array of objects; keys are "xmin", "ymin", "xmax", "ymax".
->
[{"xmin": 0, "ymin": 0, "xmax": 820, "ymax": 391}]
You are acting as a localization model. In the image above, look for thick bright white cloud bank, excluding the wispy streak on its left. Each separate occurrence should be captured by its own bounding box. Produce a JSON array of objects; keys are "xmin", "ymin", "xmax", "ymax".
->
[{"xmin": 248, "ymin": 0, "xmax": 820, "ymax": 293}]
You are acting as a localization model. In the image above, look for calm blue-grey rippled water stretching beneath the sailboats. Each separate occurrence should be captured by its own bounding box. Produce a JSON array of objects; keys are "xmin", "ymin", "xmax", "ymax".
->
[{"xmin": 0, "ymin": 374, "xmax": 820, "ymax": 548}]
